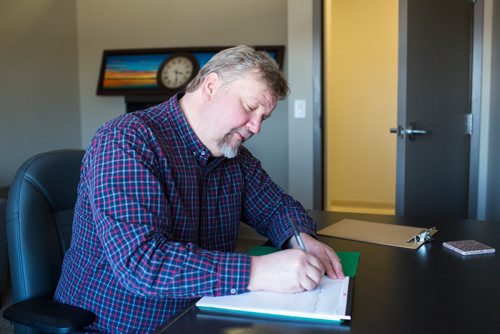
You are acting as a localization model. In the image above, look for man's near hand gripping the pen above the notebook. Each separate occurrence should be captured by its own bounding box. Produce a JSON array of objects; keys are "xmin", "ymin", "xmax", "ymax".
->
[{"xmin": 248, "ymin": 249, "xmax": 325, "ymax": 293}]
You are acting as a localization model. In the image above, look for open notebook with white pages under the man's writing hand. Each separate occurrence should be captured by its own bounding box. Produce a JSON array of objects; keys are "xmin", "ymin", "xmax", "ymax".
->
[{"xmin": 196, "ymin": 276, "xmax": 354, "ymax": 322}]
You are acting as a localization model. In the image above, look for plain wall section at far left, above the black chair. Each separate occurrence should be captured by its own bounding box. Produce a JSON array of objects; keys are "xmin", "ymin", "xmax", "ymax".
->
[{"xmin": 0, "ymin": 0, "xmax": 81, "ymax": 187}]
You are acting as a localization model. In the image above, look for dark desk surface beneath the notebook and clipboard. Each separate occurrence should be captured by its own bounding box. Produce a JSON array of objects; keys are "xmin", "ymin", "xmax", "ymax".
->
[{"xmin": 157, "ymin": 211, "xmax": 500, "ymax": 334}]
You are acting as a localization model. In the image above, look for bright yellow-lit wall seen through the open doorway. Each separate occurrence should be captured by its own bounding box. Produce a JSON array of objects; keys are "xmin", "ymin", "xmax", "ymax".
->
[{"xmin": 324, "ymin": 0, "xmax": 398, "ymax": 213}]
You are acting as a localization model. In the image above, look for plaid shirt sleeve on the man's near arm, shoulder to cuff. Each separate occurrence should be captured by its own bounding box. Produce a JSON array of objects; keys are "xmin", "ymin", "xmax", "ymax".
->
[{"xmin": 84, "ymin": 123, "xmax": 250, "ymax": 298}]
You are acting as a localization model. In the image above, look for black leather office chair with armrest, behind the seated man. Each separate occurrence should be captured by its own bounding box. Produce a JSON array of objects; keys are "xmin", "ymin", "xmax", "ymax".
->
[{"xmin": 3, "ymin": 149, "xmax": 95, "ymax": 334}]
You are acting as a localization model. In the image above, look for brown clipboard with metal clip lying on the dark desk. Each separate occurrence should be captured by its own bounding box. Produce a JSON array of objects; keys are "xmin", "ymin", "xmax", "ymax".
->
[{"xmin": 317, "ymin": 219, "xmax": 438, "ymax": 249}]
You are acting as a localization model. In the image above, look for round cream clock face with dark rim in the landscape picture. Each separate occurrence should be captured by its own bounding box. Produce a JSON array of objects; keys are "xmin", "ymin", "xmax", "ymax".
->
[{"xmin": 158, "ymin": 55, "xmax": 198, "ymax": 90}]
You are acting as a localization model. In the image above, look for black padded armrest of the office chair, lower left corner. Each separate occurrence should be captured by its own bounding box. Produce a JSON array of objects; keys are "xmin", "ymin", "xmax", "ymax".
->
[{"xmin": 3, "ymin": 298, "xmax": 95, "ymax": 333}]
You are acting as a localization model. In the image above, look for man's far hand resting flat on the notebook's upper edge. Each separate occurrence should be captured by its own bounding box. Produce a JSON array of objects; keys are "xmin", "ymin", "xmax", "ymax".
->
[{"xmin": 289, "ymin": 233, "xmax": 344, "ymax": 279}]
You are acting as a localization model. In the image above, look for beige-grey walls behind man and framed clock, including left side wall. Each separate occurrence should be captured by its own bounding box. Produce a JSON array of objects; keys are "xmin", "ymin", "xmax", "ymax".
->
[{"xmin": 0, "ymin": 0, "xmax": 296, "ymax": 200}]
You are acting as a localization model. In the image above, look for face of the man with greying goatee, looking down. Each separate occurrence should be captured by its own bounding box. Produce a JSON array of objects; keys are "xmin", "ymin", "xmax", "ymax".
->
[{"xmin": 206, "ymin": 73, "xmax": 277, "ymax": 158}]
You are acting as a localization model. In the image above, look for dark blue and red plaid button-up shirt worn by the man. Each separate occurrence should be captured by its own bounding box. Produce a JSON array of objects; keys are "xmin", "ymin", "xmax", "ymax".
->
[{"xmin": 55, "ymin": 96, "xmax": 316, "ymax": 333}]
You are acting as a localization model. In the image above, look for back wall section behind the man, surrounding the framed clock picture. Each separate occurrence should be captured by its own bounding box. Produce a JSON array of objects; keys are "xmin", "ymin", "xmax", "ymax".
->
[{"xmin": 76, "ymin": 0, "xmax": 288, "ymax": 190}]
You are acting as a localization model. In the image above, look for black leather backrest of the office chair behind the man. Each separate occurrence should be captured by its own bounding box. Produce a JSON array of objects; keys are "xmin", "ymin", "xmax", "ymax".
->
[{"xmin": 7, "ymin": 149, "xmax": 84, "ymax": 302}]
